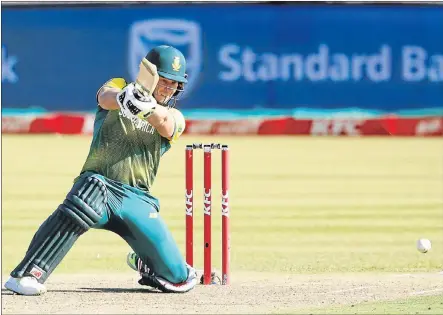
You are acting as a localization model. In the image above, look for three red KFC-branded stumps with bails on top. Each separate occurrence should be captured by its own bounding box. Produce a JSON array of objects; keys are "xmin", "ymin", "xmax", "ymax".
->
[{"xmin": 185, "ymin": 143, "xmax": 230, "ymax": 285}]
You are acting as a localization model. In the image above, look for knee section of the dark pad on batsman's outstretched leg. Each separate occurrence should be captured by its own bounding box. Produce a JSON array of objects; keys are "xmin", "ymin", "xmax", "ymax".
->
[{"xmin": 58, "ymin": 176, "xmax": 107, "ymax": 231}]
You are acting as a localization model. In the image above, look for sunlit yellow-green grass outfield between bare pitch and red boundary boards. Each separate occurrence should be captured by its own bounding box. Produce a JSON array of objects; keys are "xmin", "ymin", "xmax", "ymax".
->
[{"xmin": 2, "ymin": 135, "xmax": 443, "ymax": 274}]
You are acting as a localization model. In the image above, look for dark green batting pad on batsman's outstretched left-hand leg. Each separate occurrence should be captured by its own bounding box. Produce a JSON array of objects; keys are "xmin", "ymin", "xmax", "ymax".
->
[{"xmin": 11, "ymin": 176, "xmax": 107, "ymax": 283}]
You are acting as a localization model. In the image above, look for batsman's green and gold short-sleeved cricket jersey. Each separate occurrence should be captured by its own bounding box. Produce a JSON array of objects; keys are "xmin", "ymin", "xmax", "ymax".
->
[{"xmin": 82, "ymin": 78, "xmax": 185, "ymax": 191}]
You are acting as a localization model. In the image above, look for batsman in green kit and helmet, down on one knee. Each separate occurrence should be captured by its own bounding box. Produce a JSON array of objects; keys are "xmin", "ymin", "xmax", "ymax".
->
[{"xmin": 5, "ymin": 46, "xmax": 197, "ymax": 295}]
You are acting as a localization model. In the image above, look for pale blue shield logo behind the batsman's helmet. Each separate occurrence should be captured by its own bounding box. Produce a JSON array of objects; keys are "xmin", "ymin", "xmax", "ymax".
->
[{"xmin": 129, "ymin": 19, "xmax": 201, "ymax": 98}]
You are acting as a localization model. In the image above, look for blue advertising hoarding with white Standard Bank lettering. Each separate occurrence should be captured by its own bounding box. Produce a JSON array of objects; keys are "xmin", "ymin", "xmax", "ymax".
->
[{"xmin": 1, "ymin": 4, "xmax": 443, "ymax": 111}]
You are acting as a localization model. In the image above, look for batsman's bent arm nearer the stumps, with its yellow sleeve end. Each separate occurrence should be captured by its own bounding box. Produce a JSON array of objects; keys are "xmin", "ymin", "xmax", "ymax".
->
[{"xmin": 146, "ymin": 105, "xmax": 185, "ymax": 142}]
